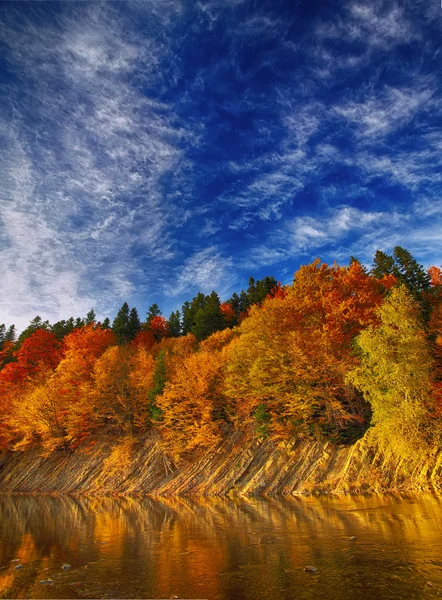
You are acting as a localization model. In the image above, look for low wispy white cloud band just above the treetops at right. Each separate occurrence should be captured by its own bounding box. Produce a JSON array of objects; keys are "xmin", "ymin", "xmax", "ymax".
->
[{"xmin": 241, "ymin": 202, "xmax": 442, "ymax": 269}]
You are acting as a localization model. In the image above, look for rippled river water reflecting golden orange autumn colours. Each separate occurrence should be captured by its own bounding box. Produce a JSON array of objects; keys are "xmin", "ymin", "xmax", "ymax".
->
[{"xmin": 0, "ymin": 495, "xmax": 442, "ymax": 600}]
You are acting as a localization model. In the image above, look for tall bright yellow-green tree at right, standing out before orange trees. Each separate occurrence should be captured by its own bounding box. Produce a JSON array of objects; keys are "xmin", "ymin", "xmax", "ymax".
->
[{"xmin": 347, "ymin": 286, "xmax": 432, "ymax": 463}]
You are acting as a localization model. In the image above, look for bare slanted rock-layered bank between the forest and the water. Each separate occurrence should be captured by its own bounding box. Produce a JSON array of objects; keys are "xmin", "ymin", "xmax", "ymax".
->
[{"xmin": 0, "ymin": 438, "xmax": 442, "ymax": 496}]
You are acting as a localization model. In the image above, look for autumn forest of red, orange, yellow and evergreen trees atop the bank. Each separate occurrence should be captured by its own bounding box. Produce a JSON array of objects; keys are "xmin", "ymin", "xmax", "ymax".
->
[{"xmin": 0, "ymin": 247, "xmax": 442, "ymax": 472}]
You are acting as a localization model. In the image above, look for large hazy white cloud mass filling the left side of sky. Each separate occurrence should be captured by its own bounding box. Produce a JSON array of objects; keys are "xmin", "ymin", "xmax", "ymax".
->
[{"xmin": 0, "ymin": 4, "xmax": 188, "ymax": 326}]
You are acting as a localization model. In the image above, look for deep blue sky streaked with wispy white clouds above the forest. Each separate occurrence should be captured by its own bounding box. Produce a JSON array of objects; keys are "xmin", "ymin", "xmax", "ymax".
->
[{"xmin": 0, "ymin": 0, "xmax": 442, "ymax": 329}]
